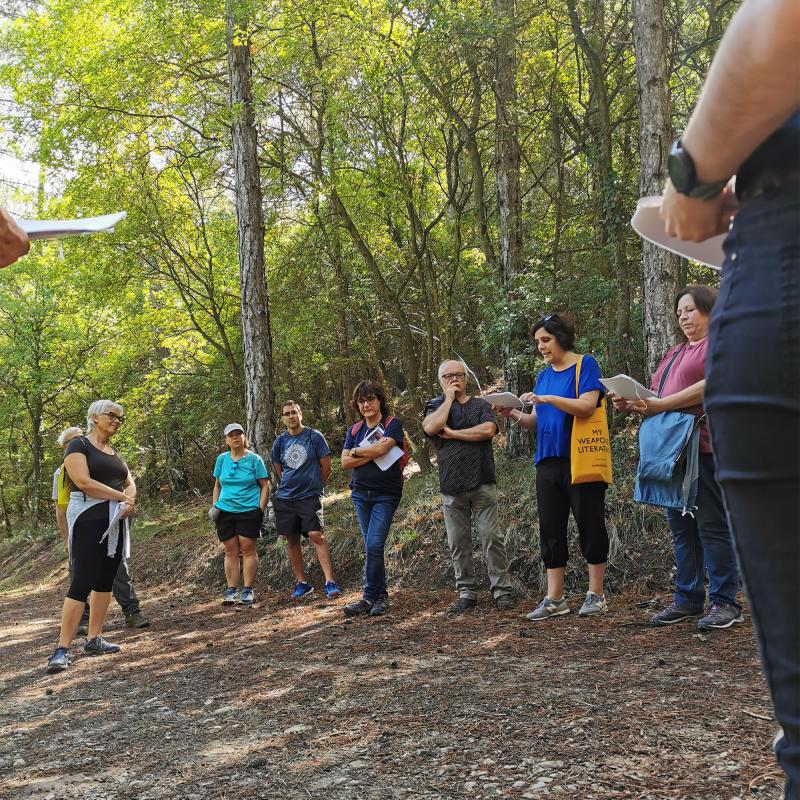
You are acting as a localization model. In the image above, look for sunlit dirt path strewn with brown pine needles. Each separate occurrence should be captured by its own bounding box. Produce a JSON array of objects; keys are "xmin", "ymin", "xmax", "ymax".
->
[{"xmin": 0, "ymin": 586, "xmax": 780, "ymax": 800}]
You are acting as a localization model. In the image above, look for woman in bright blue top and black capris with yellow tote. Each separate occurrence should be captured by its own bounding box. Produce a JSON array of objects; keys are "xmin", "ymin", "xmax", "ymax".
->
[{"xmin": 495, "ymin": 314, "xmax": 610, "ymax": 622}]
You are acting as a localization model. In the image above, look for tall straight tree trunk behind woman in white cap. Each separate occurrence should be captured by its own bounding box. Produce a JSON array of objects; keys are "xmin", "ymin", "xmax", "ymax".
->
[{"xmin": 225, "ymin": 0, "xmax": 275, "ymax": 457}]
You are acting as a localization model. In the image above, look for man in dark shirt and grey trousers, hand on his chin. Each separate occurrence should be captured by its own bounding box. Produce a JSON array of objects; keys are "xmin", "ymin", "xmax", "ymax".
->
[{"xmin": 422, "ymin": 361, "xmax": 515, "ymax": 614}]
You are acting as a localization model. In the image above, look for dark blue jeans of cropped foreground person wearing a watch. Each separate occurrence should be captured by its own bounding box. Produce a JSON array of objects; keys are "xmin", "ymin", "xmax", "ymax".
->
[{"xmin": 705, "ymin": 187, "xmax": 800, "ymax": 800}]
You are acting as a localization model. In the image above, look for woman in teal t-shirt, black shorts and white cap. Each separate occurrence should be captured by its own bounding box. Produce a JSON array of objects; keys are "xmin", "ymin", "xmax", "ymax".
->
[{"xmin": 209, "ymin": 422, "xmax": 269, "ymax": 606}]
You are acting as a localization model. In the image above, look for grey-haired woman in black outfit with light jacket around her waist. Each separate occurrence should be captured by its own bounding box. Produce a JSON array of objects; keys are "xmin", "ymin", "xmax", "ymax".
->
[{"xmin": 47, "ymin": 400, "xmax": 136, "ymax": 673}]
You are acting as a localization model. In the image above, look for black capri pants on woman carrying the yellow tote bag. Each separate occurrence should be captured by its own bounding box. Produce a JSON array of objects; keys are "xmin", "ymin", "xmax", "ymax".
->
[{"xmin": 536, "ymin": 458, "xmax": 608, "ymax": 569}]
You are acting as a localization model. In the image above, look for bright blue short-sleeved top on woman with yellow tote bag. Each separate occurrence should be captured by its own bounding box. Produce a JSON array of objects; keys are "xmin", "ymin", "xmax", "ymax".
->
[{"xmin": 533, "ymin": 355, "xmax": 605, "ymax": 464}]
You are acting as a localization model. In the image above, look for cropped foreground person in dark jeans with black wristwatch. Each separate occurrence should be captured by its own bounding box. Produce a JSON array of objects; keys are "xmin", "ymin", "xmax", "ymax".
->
[{"xmin": 662, "ymin": 0, "xmax": 800, "ymax": 800}]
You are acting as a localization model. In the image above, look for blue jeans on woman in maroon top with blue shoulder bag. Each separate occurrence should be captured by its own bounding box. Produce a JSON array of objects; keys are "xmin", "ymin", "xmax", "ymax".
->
[{"xmin": 665, "ymin": 453, "xmax": 741, "ymax": 611}]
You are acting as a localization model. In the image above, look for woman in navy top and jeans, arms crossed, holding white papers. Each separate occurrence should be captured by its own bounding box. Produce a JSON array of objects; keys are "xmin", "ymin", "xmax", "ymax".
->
[{"xmin": 342, "ymin": 380, "xmax": 403, "ymax": 617}]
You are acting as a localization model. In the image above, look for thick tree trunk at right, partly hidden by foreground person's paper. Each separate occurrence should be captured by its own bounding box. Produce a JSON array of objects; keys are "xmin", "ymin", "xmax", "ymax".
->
[{"xmin": 633, "ymin": 0, "xmax": 680, "ymax": 375}]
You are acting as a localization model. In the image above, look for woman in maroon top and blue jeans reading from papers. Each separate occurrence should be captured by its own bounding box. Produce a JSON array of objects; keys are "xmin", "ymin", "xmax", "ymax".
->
[{"xmin": 613, "ymin": 284, "xmax": 743, "ymax": 630}]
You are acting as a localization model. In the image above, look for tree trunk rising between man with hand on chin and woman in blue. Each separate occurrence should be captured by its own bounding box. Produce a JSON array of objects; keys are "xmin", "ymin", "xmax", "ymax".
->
[{"xmin": 494, "ymin": 0, "xmax": 531, "ymax": 456}]
